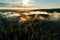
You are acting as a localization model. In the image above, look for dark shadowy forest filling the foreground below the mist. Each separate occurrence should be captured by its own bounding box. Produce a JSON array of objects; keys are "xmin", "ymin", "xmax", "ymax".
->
[{"xmin": 0, "ymin": 17, "xmax": 60, "ymax": 40}]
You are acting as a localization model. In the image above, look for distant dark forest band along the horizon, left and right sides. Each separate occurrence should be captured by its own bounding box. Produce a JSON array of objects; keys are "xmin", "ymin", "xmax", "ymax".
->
[{"xmin": 0, "ymin": 8, "xmax": 60, "ymax": 13}]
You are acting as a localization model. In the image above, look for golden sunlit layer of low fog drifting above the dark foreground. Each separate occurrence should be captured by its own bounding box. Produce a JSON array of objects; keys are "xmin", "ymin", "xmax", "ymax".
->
[{"xmin": 0, "ymin": 12, "xmax": 60, "ymax": 22}]
